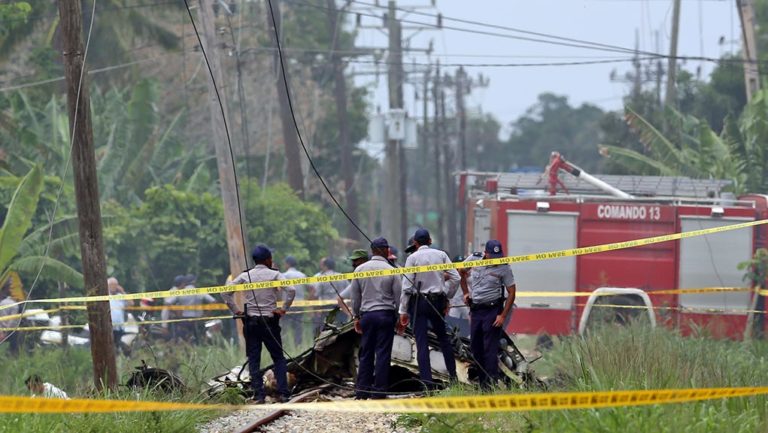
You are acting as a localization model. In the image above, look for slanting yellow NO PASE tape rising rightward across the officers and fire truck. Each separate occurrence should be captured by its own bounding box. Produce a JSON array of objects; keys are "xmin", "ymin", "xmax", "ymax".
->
[{"xmin": 0, "ymin": 220, "xmax": 768, "ymax": 310}]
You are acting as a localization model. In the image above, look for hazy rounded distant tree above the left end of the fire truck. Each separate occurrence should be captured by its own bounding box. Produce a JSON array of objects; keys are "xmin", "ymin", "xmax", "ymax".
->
[{"xmin": 507, "ymin": 93, "xmax": 604, "ymax": 172}]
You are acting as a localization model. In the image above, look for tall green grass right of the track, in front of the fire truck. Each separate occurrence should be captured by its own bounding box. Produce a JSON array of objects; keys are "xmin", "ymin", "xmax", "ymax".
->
[{"xmin": 399, "ymin": 326, "xmax": 768, "ymax": 433}]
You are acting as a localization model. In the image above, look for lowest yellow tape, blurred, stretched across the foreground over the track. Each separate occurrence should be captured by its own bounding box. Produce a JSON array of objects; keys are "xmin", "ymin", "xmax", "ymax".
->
[{"xmin": 0, "ymin": 387, "xmax": 768, "ymax": 413}]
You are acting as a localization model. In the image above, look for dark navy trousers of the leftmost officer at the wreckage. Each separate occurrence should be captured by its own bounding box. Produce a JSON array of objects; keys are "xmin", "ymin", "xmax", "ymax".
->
[{"xmin": 244, "ymin": 316, "xmax": 291, "ymax": 400}]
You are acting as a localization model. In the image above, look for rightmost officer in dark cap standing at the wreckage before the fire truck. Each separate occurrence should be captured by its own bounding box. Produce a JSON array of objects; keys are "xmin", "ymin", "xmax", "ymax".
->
[{"xmin": 461, "ymin": 239, "xmax": 516, "ymax": 387}]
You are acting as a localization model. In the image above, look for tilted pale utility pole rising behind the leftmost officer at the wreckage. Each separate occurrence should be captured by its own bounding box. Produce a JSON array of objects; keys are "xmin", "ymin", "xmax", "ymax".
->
[{"xmin": 199, "ymin": 0, "xmax": 248, "ymax": 290}]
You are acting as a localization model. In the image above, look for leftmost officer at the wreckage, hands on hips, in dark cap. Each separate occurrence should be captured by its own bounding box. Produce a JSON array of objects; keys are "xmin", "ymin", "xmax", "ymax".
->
[{"xmin": 221, "ymin": 245, "xmax": 296, "ymax": 403}]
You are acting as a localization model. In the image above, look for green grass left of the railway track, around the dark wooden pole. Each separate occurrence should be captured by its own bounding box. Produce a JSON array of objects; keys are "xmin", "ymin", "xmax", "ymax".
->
[{"xmin": 0, "ymin": 320, "xmax": 320, "ymax": 433}]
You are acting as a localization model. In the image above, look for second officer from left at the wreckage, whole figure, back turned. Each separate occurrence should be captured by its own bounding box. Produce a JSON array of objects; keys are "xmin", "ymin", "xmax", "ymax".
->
[{"xmin": 350, "ymin": 238, "xmax": 401, "ymax": 399}]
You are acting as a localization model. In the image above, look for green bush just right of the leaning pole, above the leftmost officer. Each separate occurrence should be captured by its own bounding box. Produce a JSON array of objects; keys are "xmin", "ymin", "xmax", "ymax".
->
[{"xmin": 241, "ymin": 181, "xmax": 338, "ymax": 268}]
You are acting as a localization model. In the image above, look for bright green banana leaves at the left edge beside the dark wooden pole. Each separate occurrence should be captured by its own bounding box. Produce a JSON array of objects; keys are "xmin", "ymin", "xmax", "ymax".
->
[{"xmin": 0, "ymin": 165, "xmax": 83, "ymax": 287}]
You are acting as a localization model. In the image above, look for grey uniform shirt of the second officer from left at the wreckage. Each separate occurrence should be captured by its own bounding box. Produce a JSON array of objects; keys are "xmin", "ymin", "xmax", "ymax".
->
[{"xmin": 350, "ymin": 256, "xmax": 401, "ymax": 316}]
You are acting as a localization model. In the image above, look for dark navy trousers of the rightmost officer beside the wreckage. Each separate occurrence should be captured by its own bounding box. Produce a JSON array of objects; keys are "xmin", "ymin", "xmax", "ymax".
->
[{"xmin": 469, "ymin": 305, "xmax": 501, "ymax": 387}]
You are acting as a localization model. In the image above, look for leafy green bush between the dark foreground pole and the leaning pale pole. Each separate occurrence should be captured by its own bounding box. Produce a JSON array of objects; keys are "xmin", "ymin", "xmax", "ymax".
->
[{"xmin": 104, "ymin": 185, "xmax": 229, "ymax": 291}]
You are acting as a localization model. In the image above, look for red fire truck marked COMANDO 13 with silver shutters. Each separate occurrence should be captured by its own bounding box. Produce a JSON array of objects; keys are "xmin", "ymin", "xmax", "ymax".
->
[{"xmin": 459, "ymin": 152, "xmax": 768, "ymax": 339}]
